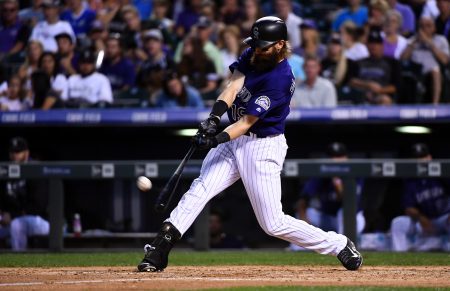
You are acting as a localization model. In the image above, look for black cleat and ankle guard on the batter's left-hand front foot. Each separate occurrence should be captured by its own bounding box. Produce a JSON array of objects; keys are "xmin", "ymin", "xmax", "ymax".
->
[{"xmin": 137, "ymin": 222, "xmax": 181, "ymax": 272}]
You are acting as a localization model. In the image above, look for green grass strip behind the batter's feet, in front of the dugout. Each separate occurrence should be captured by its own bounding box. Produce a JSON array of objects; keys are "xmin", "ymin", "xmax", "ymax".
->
[{"xmin": 0, "ymin": 250, "xmax": 450, "ymax": 267}]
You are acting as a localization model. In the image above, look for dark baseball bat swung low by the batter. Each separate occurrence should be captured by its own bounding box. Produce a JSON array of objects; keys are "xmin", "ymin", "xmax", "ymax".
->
[{"xmin": 155, "ymin": 145, "xmax": 196, "ymax": 213}]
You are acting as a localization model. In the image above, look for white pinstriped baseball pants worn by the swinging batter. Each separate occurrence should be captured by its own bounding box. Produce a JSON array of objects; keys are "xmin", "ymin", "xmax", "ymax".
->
[{"xmin": 167, "ymin": 134, "xmax": 347, "ymax": 255}]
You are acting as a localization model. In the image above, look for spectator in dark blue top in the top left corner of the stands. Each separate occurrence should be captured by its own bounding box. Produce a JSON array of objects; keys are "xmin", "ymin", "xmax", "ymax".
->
[{"xmin": 0, "ymin": 0, "xmax": 30, "ymax": 57}]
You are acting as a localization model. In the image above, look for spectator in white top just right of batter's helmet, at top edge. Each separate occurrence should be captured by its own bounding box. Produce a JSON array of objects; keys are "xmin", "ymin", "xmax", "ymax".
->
[{"xmin": 274, "ymin": 0, "xmax": 302, "ymax": 50}]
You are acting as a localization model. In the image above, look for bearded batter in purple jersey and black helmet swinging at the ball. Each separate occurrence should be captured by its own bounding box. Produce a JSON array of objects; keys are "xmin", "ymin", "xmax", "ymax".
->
[{"xmin": 138, "ymin": 16, "xmax": 362, "ymax": 272}]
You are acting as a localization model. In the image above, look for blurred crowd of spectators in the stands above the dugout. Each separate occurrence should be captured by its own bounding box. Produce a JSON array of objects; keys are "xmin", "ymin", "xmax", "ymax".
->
[{"xmin": 0, "ymin": 0, "xmax": 450, "ymax": 111}]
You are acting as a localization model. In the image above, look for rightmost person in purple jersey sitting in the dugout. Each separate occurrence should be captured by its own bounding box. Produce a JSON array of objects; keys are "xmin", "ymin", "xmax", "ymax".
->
[{"xmin": 391, "ymin": 143, "xmax": 450, "ymax": 252}]
